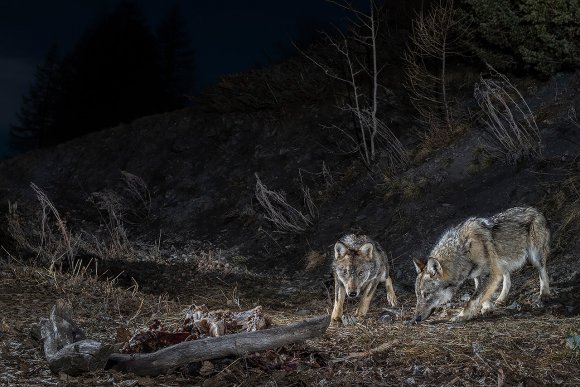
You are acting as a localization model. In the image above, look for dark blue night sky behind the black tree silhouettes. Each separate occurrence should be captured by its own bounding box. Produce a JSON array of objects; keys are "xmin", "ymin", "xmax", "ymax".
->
[{"xmin": 0, "ymin": 0, "xmax": 362, "ymax": 158}]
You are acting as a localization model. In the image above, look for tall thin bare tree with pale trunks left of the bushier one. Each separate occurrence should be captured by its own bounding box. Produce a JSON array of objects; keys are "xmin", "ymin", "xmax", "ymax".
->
[{"xmin": 302, "ymin": 0, "xmax": 408, "ymax": 169}]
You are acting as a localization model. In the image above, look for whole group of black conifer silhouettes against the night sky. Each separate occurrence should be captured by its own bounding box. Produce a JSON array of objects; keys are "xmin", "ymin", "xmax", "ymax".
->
[{"xmin": 12, "ymin": 0, "xmax": 193, "ymax": 149}]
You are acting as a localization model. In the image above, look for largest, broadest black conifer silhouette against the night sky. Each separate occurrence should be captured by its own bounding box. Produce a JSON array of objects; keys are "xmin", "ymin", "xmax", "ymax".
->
[{"xmin": 51, "ymin": 1, "xmax": 165, "ymax": 143}]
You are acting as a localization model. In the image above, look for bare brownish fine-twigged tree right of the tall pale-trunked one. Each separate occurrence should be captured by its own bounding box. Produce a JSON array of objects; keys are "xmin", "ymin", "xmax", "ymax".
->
[{"xmin": 403, "ymin": 0, "xmax": 469, "ymax": 132}]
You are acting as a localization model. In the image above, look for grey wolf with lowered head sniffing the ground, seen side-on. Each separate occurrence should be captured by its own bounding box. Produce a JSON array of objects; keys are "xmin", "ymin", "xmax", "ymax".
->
[{"xmin": 414, "ymin": 207, "xmax": 550, "ymax": 322}]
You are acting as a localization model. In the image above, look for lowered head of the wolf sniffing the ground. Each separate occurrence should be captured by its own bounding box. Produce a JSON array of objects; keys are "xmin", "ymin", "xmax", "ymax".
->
[{"xmin": 413, "ymin": 258, "xmax": 456, "ymax": 322}]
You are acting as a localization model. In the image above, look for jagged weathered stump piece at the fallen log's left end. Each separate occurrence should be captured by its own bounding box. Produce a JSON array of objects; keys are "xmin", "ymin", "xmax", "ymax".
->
[{"xmin": 36, "ymin": 300, "xmax": 118, "ymax": 376}]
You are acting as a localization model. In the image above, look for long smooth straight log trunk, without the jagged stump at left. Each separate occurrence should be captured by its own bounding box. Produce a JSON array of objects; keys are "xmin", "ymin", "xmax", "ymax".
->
[{"xmin": 105, "ymin": 316, "xmax": 330, "ymax": 376}]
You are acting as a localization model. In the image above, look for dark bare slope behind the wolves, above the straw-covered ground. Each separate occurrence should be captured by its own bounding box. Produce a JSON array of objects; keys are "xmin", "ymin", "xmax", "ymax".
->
[{"xmin": 0, "ymin": 74, "xmax": 580, "ymax": 282}]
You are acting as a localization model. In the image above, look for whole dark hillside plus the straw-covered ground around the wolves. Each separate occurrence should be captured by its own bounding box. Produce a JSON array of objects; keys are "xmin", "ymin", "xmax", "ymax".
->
[{"xmin": 0, "ymin": 64, "xmax": 580, "ymax": 385}]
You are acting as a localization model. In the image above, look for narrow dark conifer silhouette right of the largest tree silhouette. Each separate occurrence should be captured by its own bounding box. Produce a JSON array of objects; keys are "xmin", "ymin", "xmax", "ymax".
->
[{"xmin": 157, "ymin": 5, "xmax": 195, "ymax": 109}]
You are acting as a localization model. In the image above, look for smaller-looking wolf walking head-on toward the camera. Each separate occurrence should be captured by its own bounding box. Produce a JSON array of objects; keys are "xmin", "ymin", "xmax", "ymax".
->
[{"xmin": 332, "ymin": 234, "xmax": 397, "ymax": 321}]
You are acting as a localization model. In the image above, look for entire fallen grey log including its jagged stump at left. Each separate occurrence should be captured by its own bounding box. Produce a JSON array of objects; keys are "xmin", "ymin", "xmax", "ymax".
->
[{"xmin": 32, "ymin": 300, "xmax": 330, "ymax": 376}]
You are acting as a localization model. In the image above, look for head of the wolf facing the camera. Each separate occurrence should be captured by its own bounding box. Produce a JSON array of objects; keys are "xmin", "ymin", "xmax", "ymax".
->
[{"xmin": 333, "ymin": 242, "xmax": 379, "ymax": 297}]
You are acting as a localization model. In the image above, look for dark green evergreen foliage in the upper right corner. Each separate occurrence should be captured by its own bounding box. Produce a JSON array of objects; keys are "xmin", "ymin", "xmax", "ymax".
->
[{"xmin": 463, "ymin": 0, "xmax": 580, "ymax": 74}]
